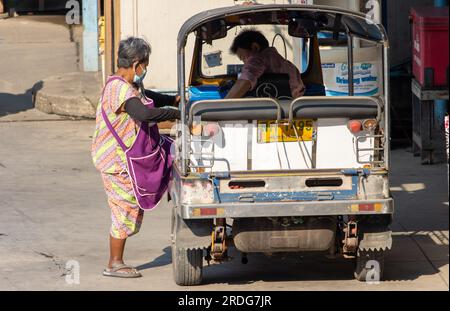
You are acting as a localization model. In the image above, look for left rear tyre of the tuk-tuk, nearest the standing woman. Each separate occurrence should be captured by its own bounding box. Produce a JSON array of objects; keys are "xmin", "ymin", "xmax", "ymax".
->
[{"xmin": 172, "ymin": 208, "xmax": 203, "ymax": 286}]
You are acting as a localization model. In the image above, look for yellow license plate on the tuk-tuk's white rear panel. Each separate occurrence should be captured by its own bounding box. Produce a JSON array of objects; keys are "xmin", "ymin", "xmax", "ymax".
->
[{"xmin": 258, "ymin": 119, "xmax": 314, "ymax": 143}]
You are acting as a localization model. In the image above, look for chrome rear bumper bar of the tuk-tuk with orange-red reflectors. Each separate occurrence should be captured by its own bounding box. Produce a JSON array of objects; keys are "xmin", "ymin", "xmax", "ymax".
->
[{"xmin": 180, "ymin": 198, "xmax": 394, "ymax": 219}]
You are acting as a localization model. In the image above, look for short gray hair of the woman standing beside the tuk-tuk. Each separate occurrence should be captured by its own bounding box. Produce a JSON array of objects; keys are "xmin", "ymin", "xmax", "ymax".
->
[{"xmin": 117, "ymin": 37, "xmax": 152, "ymax": 68}]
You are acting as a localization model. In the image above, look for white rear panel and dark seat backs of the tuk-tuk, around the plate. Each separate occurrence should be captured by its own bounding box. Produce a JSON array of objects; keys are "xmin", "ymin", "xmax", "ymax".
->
[{"xmin": 189, "ymin": 97, "xmax": 381, "ymax": 171}]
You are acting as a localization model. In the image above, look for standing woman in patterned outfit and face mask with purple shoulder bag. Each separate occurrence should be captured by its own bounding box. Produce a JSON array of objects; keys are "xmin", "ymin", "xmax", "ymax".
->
[{"xmin": 92, "ymin": 37, "xmax": 180, "ymax": 278}]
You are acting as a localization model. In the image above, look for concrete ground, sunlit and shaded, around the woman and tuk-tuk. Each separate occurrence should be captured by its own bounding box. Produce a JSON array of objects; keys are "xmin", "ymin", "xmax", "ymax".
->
[{"xmin": 0, "ymin": 18, "xmax": 449, "ymax": 291}]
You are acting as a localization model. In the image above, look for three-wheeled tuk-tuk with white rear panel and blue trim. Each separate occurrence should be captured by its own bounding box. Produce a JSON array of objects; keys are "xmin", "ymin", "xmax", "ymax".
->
[{"xmin": 169, "ymin": 4, "xmax": 394, "ymax": 286}]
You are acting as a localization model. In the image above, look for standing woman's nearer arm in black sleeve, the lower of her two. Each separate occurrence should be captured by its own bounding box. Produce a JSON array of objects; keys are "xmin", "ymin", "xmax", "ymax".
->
[{"xmin": 125, "ymin": 97, "xmax": 180, "ymax": 122}]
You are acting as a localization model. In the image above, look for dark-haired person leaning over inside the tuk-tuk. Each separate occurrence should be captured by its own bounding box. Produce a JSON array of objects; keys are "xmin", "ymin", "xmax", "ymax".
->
[{"xmin": 226, "ymin": 29, "xmax": 305, "ymax": 98}]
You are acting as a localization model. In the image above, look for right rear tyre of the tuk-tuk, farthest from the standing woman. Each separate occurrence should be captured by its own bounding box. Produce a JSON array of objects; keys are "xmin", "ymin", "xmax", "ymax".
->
[{"xmin": 354, "ymin": 250, "xmax": 384, "ymax": 282}]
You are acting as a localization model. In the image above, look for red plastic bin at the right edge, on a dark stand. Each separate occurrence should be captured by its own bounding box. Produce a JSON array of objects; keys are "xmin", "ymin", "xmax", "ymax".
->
[{"xmin": 411, "ymin": 7, "xmax": 449, "ymax": 87}]
